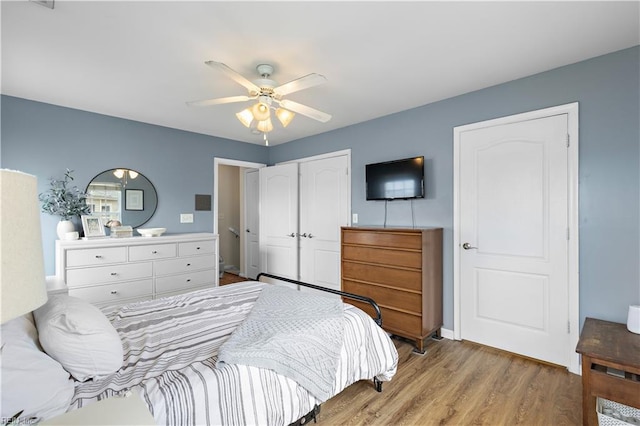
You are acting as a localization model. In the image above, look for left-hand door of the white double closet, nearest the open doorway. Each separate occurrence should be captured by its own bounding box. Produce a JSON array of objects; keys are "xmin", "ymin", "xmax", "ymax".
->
[{"xmin": 259, "ymin": 163, "xmax": 298, "ymax": 286}]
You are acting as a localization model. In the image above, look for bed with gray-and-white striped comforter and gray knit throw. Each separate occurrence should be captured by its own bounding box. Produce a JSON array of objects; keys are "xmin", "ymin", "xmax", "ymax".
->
[{"xmin": 3, "ymin": 274, "xmax": 398, "ymax": 425}]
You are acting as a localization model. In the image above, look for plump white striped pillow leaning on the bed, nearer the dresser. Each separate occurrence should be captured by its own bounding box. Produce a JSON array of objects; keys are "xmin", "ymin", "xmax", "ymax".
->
[{"xmin": 33, "ymin": 295, "xmax": 123, "ymax": 382}]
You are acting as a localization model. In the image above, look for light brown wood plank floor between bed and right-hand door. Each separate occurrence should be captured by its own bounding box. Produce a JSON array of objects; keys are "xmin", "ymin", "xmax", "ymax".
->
[{"xmin": 318, "ymin": 339, "xmax": 582, "ymax": 426}]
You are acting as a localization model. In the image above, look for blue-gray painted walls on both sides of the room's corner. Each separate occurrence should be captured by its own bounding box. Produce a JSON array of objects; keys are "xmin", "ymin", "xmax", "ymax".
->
[{"xmin": 0, "ymin": 47, "xmax": 640, "ymax": 328}]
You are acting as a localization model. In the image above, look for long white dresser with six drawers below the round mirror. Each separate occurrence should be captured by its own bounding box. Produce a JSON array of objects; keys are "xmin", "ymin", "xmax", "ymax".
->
[{"xmin": 55, "ymin": 233, "xmax": 218, "ymax": 306}]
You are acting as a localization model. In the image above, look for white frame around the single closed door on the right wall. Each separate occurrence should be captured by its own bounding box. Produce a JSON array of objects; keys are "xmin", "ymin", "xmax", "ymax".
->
[{"xmin": 453, "ymin": 102, "xmax": 581, "ymax": 374}]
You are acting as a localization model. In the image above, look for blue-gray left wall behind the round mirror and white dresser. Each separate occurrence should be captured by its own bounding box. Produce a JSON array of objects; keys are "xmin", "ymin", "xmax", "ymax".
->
[{"xmin": 0, "ymin": 96, "xmax": 268, "ymax": 275}]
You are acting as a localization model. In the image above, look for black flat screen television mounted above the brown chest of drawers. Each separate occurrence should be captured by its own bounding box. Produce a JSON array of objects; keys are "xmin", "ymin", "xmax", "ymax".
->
[{"xmin": 365, "ymin": 157, "xmax": 424, "ymax": 200}]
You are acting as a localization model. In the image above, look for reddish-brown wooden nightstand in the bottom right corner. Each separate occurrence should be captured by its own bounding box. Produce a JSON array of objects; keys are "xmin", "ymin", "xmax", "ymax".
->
[{"xmin": 576, "ymin": 318, "xmax": 640, "ymax": 426}]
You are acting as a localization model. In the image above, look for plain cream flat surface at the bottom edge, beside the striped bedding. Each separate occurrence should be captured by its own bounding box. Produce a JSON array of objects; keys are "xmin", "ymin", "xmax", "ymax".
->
[{"xmin": 39, "ymin": 393, "xmax": 156, "ymax": 426}]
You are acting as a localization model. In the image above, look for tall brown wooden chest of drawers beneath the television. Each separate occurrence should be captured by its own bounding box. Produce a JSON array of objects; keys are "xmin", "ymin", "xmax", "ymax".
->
[{"xmin": 341, "ymin": 227, "xmax": 442, "ymax": 352}]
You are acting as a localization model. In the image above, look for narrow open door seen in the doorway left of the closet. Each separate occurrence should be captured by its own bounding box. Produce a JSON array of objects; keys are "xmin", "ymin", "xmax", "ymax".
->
[{"xmin": 244, "ymin": 169, "xmax": 260, "ymax": 279}]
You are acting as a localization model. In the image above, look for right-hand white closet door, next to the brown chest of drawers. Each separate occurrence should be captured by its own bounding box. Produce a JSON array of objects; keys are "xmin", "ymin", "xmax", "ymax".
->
[{"xmin": 300, "ymin": 155, "xmax": 350, "ymax": 290}]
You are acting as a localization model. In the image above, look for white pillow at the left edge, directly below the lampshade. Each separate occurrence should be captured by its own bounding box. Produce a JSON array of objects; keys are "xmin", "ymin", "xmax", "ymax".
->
[{"xmin": 1, "ymin": 314, "xmax": 74, "ymax": 424}]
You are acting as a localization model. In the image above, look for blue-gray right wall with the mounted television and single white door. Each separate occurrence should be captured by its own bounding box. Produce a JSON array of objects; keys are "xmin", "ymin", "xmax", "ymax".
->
[{"xmin": 269, "ymin": 47, "xmax": 640, "ymax": 328}]
